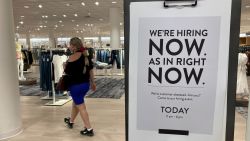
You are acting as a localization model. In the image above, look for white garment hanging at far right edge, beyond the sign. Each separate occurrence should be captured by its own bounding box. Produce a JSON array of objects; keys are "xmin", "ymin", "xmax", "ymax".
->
[{"xmin": 237, "ymin": 53, "xmax": 249, "ymax": 95}]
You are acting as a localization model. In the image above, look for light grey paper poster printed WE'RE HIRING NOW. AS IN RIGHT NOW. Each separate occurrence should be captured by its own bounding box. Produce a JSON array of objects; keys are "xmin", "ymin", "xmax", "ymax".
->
[{"xmin": 137, "ymin": 17, "xmax": 220, "ymax": 134}]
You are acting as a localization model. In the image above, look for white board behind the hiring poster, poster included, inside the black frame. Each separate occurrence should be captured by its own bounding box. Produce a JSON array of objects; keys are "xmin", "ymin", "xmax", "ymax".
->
[{"xmin": 128, "ymin": 0, "xmax": 231, "ymax": 141}]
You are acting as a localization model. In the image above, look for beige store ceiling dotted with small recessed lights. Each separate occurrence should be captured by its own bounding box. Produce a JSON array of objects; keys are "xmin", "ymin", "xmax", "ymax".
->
[{"xmin": 13, "ymin": 0, "xmax": 123, "ymax": 37}]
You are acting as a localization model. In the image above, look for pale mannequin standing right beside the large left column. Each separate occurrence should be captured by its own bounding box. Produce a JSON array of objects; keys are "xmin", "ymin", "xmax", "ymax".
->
[{"xmin": 16, "ymin": 34, "xmax": 26, "ymax": 81}]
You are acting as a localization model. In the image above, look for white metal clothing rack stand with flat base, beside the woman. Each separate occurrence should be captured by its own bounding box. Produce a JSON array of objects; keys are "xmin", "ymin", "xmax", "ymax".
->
[{"xmin": 39, "ymin": 49, "xmax": 71, "ymax": 106}]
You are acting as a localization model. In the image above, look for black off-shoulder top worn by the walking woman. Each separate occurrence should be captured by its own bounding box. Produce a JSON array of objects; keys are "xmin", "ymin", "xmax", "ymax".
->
[{"xmin": 64, "ymin": 54, "xmax": 93, "ymax": 86}]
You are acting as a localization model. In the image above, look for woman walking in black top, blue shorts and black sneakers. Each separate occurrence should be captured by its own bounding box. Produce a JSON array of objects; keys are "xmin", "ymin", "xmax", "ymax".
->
[{"xmin": 64, "ymin": 37, "xmax": 96, "ymax": 136}]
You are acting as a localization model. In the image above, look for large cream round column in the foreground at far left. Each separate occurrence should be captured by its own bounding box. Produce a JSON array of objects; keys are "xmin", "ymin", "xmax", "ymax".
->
[{"xmin": 0, "ymin": 0, "xmax": 22, "ymax": 140}]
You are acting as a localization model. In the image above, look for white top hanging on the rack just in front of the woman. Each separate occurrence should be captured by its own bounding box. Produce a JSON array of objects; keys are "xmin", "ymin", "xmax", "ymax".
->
[{"xmin": 52, "ymin": 55, "xmax": 68, "ymax": 83}]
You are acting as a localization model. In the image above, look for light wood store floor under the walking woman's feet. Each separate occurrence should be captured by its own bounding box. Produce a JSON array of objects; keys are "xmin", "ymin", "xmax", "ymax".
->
[{"xmin": 1, "ymin": 66, "xmax": 250, "ymax": 141}]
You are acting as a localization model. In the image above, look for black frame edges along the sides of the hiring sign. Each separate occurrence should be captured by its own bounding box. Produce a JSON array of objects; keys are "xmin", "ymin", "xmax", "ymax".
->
[{"xmin": 124, "ymin": 0, "xmax": 241, "ymax": 141}]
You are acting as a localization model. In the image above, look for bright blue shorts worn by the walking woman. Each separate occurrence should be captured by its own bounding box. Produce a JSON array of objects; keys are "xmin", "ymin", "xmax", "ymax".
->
[{"xmin": 69, "ymin": 83, "xmax": 89, "ymax": 105}]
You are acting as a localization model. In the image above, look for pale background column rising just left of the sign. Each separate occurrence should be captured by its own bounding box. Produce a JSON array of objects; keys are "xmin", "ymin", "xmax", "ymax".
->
[{"xmin": 109, "ymin": 8, "xmax": 120, "ymax": 49}]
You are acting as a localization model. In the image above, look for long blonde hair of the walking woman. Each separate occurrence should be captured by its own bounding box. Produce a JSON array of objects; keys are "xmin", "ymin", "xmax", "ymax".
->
[{"xmin": 69, "ymin": 37, "xmax": 89, "ymax": 73}]
